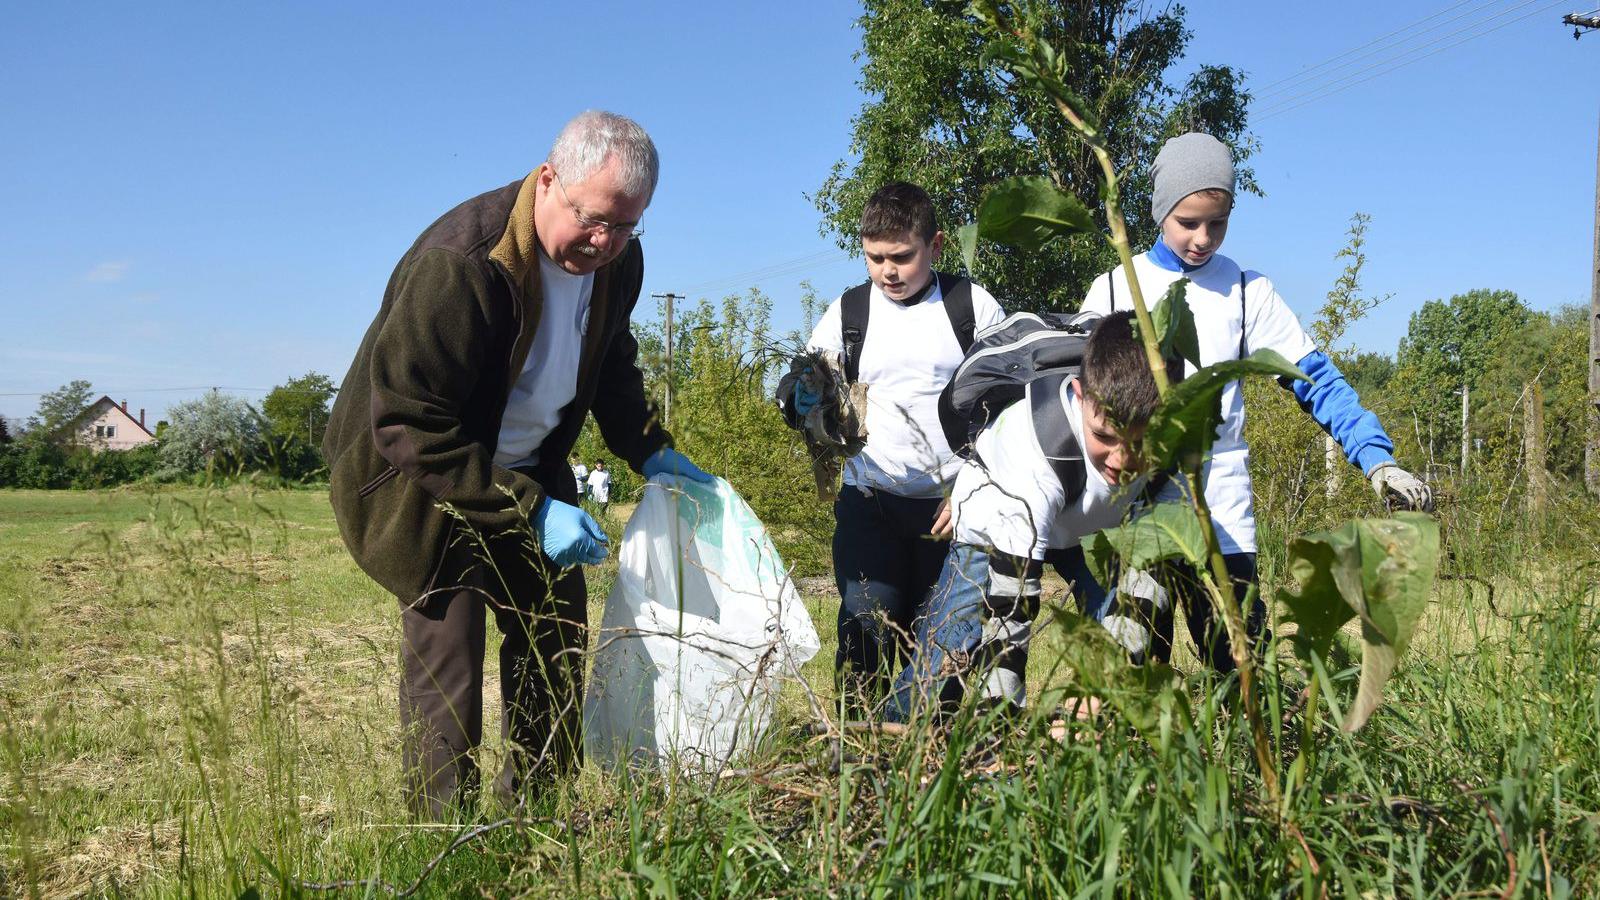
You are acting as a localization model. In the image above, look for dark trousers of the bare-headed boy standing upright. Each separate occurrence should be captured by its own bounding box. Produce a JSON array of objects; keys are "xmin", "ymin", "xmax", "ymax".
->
[{"xmin": 834, "ymin": 485, "xmax": 950, "ymax": 703}]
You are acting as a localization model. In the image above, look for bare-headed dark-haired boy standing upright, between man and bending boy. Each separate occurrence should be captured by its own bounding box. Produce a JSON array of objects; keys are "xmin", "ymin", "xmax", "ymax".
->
[{"xmin": 779, "ymin": 183, "xmax": 1005, "ymax": 705}]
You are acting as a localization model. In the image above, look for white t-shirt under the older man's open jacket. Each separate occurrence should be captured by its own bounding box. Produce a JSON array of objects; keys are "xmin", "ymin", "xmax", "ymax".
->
[{"xmin": 494, "ymin": 251, "xmax": 595, "ymax": 469}]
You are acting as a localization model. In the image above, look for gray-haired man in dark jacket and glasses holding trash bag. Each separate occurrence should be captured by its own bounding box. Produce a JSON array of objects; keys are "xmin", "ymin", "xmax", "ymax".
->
[{"xmin": 323, "ymin": 110, "xmax": 710, "ymax": 818}]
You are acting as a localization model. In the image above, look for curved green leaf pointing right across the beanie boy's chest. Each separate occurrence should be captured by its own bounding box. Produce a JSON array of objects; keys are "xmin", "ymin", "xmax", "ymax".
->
[{"xmin": 1144, "ymin": 351, "xmax": 1307, "ymax": 469}]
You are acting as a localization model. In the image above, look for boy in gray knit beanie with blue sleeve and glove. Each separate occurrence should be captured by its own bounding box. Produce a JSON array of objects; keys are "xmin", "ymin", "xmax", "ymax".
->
[{"xmin": 1083, "ymin": 133, "xmax": 1432, "ymax": 673}]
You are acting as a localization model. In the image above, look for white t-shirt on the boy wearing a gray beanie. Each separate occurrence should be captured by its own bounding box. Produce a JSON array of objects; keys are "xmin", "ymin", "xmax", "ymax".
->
[{"xmin": 1083, "ymin": 253, "xmax": 1317, "ymax": 552}]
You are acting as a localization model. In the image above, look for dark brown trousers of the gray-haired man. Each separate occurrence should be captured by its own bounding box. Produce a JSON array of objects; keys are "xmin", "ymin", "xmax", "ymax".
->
[{"xmin": 400, "ymin": 466, "xmax": 589, "ymax": 818}]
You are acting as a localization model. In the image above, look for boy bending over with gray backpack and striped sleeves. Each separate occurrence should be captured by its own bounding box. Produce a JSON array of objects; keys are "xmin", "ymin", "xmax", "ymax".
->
[{"xmin": 888, "ymin": 312, "xmax": 1158, "ymax": 721}]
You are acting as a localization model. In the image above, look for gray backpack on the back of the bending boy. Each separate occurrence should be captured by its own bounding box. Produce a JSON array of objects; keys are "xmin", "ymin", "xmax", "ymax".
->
[{"xmin": 939, "ymin": 312, "xmax": 1101, "ymax": 501}]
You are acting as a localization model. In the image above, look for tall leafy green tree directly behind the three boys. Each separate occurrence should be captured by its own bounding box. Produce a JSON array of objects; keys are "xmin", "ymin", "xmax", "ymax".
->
[{"xmin": 813, "ymin": 0, "xmax": 1256, "ymax": 311}]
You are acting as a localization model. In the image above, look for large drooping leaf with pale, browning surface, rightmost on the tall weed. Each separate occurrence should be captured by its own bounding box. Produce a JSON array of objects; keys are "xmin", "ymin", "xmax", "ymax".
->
[{"xmin": 1283, "ymin": 512, "xmax": 1438, "ymax": 732}]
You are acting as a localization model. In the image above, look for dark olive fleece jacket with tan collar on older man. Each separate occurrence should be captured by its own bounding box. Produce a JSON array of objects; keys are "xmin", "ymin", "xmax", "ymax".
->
[{"xmin": 322, "ymin": 170, "xmax": 670, "ymax": 602}]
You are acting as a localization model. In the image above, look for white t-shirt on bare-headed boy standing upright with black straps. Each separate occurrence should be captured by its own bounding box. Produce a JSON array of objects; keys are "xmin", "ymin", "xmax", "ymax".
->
[{"xmin": 806, "ymin": 279, "xmax": 1005, "ymax": 498}]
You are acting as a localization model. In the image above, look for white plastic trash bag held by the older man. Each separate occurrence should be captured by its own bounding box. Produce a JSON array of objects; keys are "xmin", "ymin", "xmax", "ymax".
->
[{"xmin": 584, "ymin": 476, "xmax": 821, "ymax": 770}]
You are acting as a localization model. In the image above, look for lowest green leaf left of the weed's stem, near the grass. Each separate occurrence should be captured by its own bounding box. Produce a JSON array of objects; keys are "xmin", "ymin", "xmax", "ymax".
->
[{"xmin": 1054, "ymin": 610, "xmax": 1190, "ymax": 735}]
